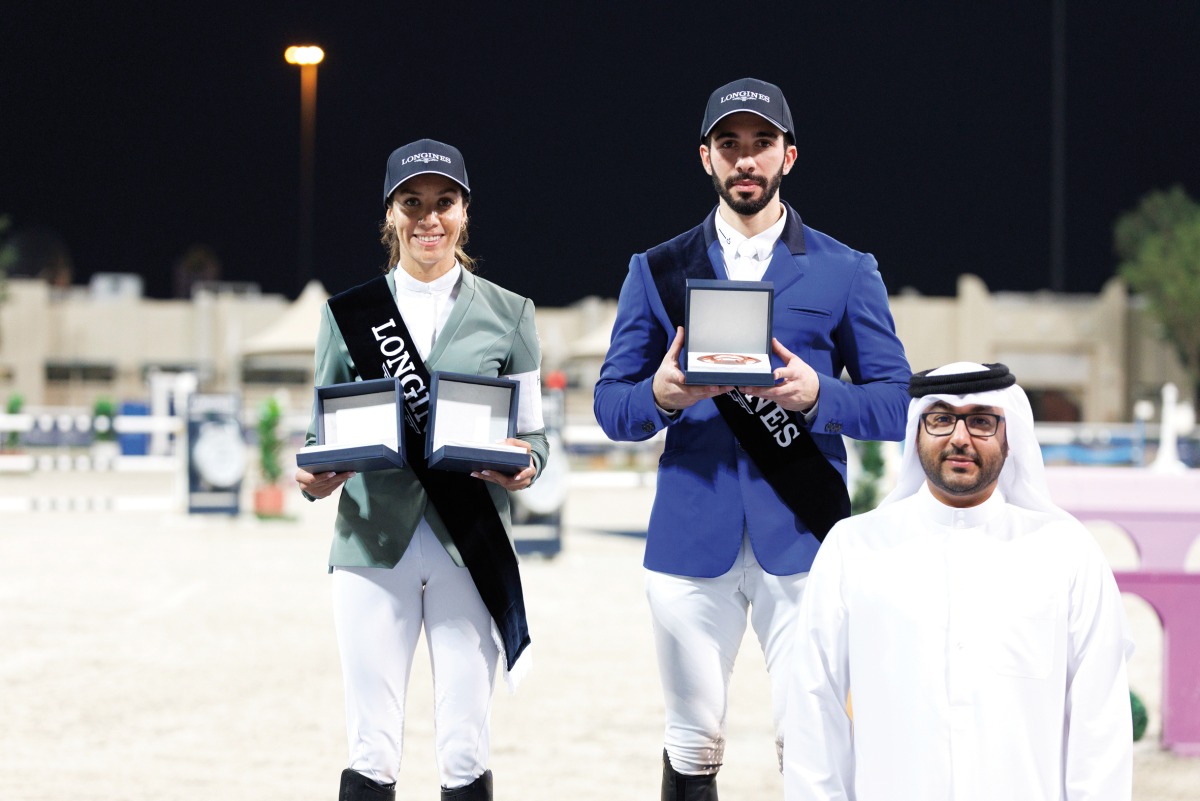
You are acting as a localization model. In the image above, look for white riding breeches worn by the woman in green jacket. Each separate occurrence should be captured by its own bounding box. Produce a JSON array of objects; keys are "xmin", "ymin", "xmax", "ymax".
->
[{"xmin": 332, "ymin": 520, "xmax": 499, "ymax": 788}]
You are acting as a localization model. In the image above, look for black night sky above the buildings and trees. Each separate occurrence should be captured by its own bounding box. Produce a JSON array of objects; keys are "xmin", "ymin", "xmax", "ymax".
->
[{"xmin": 0, "ymin": 0, "xmax": 1200, "ymax": 306}]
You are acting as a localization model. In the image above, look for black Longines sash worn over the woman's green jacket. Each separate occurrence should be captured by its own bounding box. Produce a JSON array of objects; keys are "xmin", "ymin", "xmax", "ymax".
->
[{"xmin": 329, "ymin": 276, "xmax": 529, "ymax": 670}]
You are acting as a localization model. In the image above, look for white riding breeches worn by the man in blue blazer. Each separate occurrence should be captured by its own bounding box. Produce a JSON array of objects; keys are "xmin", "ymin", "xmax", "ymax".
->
[{"xmin": 646, "ymin": 537, "xmax": 808, "ymax": 775}]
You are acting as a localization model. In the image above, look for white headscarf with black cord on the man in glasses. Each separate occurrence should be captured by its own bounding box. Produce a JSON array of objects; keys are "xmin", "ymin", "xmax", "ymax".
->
[{"xmin": 880, "ymin": 362, "xmax": 1070, "ymax": 518}]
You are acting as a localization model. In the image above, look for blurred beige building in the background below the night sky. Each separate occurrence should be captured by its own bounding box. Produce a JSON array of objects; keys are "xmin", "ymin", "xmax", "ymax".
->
[{"xmin": 0, "ymin": 268, "xmax": 1188, "ymax": 423}]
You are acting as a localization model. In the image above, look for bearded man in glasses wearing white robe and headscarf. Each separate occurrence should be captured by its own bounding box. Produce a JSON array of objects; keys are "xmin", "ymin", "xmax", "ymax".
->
[{"xmin": 784, "ymin": 362, "xmax": 1133, "ymax": 801}]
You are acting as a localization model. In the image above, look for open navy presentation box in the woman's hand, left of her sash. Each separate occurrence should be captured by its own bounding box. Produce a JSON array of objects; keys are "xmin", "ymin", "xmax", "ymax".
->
[{"xmin": 296, "ymin": 378, "xmax": 404, "ymax": 474}]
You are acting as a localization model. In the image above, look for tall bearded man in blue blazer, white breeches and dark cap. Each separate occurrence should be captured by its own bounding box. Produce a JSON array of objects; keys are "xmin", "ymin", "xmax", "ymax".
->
[{"xmin": 595, "ymin": 78, "xmax": 911, "ymax": 801}]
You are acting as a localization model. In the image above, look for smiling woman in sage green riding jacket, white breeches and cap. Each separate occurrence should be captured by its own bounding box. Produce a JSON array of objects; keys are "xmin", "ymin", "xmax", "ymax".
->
[{"xmin": 296, "ymin": 139, "xmax": 547, "ymax": 801}]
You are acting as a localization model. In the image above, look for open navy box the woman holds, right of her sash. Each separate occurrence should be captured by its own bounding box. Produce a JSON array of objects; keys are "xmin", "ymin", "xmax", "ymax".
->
[{"xmin": 425, "ymin": 372, "xmax": 529, "ymax": 475}]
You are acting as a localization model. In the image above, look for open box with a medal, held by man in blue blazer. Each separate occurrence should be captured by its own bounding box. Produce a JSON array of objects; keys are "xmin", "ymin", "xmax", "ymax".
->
[{"xmin": 683, "ymin": 278, "xmax": 775, "ymax": 386}]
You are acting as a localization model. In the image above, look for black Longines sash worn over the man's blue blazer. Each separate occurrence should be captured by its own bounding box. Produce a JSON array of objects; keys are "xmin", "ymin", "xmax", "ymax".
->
[{"xmin": 646, "ymin": 231, "xmax": 850, "ymax": 541}]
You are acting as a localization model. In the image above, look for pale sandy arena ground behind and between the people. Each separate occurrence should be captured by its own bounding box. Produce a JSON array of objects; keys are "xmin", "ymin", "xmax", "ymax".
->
[{"xmin": 0, "ymin": 474, "xmax": 1200, "ymax": 801}]
